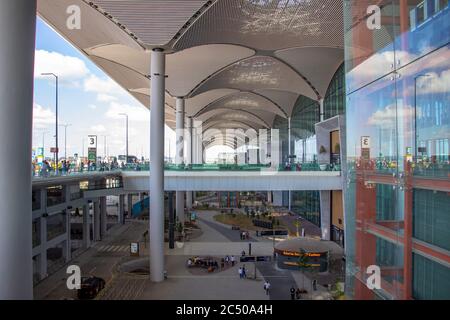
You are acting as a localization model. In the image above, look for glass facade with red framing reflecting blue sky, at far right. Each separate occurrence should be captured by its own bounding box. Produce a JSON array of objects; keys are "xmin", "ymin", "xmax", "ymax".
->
[{"xmin": 344, "ymin": 0, "xmax": 450, "ymax": 299}]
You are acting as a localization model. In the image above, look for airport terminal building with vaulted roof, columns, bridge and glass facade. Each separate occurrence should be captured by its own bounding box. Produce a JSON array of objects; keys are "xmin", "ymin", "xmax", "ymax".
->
[{"xmin": 0, "ymin": 0, "xmax": 450, "ymax": 300}]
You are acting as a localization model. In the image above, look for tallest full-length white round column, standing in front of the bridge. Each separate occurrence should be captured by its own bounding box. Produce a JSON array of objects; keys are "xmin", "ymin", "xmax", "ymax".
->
[{"xmin": 149, "ymin": 49, "xmax": 166, "ymax": 282}]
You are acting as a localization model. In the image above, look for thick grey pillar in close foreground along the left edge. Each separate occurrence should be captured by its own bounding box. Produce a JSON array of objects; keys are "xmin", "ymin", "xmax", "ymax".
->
[{"xmin": 0, "ymin": 0, "xmax": 36, "ymax": 300}]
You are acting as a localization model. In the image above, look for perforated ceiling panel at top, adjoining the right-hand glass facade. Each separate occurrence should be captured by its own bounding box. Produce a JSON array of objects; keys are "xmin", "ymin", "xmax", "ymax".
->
[{"xmin": 174, "ymin": 0, "xmax": 344, "ymax": 50}]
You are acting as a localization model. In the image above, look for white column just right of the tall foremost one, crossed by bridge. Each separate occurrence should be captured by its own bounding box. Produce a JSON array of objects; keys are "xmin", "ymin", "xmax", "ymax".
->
[{"xmin": 175, "ymin": 98, "xmax": 185, "ymax": 223}]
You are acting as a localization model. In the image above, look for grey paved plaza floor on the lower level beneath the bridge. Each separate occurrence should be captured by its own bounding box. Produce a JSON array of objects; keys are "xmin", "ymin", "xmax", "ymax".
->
[{"xmin": 35, "ymin": 211, "xmax": 342, "ymax": 300}]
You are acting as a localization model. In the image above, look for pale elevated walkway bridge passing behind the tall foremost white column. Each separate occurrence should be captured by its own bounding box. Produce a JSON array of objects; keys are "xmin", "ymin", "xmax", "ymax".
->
[{"xmin": 33, "ymin": 167, "xmax": 342, "ymax": 192}]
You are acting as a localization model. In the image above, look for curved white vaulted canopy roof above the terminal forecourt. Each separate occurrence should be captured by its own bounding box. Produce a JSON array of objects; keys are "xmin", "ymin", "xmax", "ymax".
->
[{"xmin": 38, "ymin": 0, "xmax": 344, "ymax": 134}]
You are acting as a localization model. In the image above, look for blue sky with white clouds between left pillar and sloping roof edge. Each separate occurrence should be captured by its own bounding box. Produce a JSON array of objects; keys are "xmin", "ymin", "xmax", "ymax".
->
[{"xmin": 33, "ymin": 19, "xmax": 175, "ymax": 159}]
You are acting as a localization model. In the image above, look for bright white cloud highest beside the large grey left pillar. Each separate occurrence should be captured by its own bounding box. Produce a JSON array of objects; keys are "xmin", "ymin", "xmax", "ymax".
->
[{"xmin": 34, "ymin": 50, "xmax": 89, "ymax": 82}]
